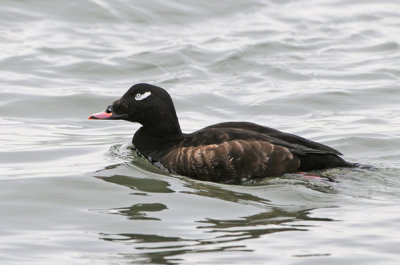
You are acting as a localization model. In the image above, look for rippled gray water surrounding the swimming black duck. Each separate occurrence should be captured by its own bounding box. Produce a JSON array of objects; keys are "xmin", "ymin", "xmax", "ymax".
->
[{"xmin": 0, "ymin": 0, "xmax": 400, "ymax": 265}]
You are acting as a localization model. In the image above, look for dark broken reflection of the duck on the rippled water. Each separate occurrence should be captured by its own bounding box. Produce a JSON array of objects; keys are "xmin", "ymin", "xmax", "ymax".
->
[{"xmin": 96, "ymin": 164, "xmax": 334, "ymax": 264}]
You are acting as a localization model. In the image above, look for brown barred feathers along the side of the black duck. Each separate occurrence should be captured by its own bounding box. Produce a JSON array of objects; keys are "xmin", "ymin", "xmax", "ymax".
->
[{"xmin": 160, "ymin": 140, "xmax": 300, "ymax": 183}]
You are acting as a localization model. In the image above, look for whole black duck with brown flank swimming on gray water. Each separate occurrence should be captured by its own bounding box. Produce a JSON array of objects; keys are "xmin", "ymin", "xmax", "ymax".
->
[{"xmin": 89, "ymin": 84, "xmax": 354, "ymax": 183}]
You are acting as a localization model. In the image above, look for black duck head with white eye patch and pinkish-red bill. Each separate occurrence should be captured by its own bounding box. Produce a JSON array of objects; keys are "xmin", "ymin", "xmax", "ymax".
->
[{"xmin": 89, "ymin": 83, "xmax": 182, "ymax": 136}]
